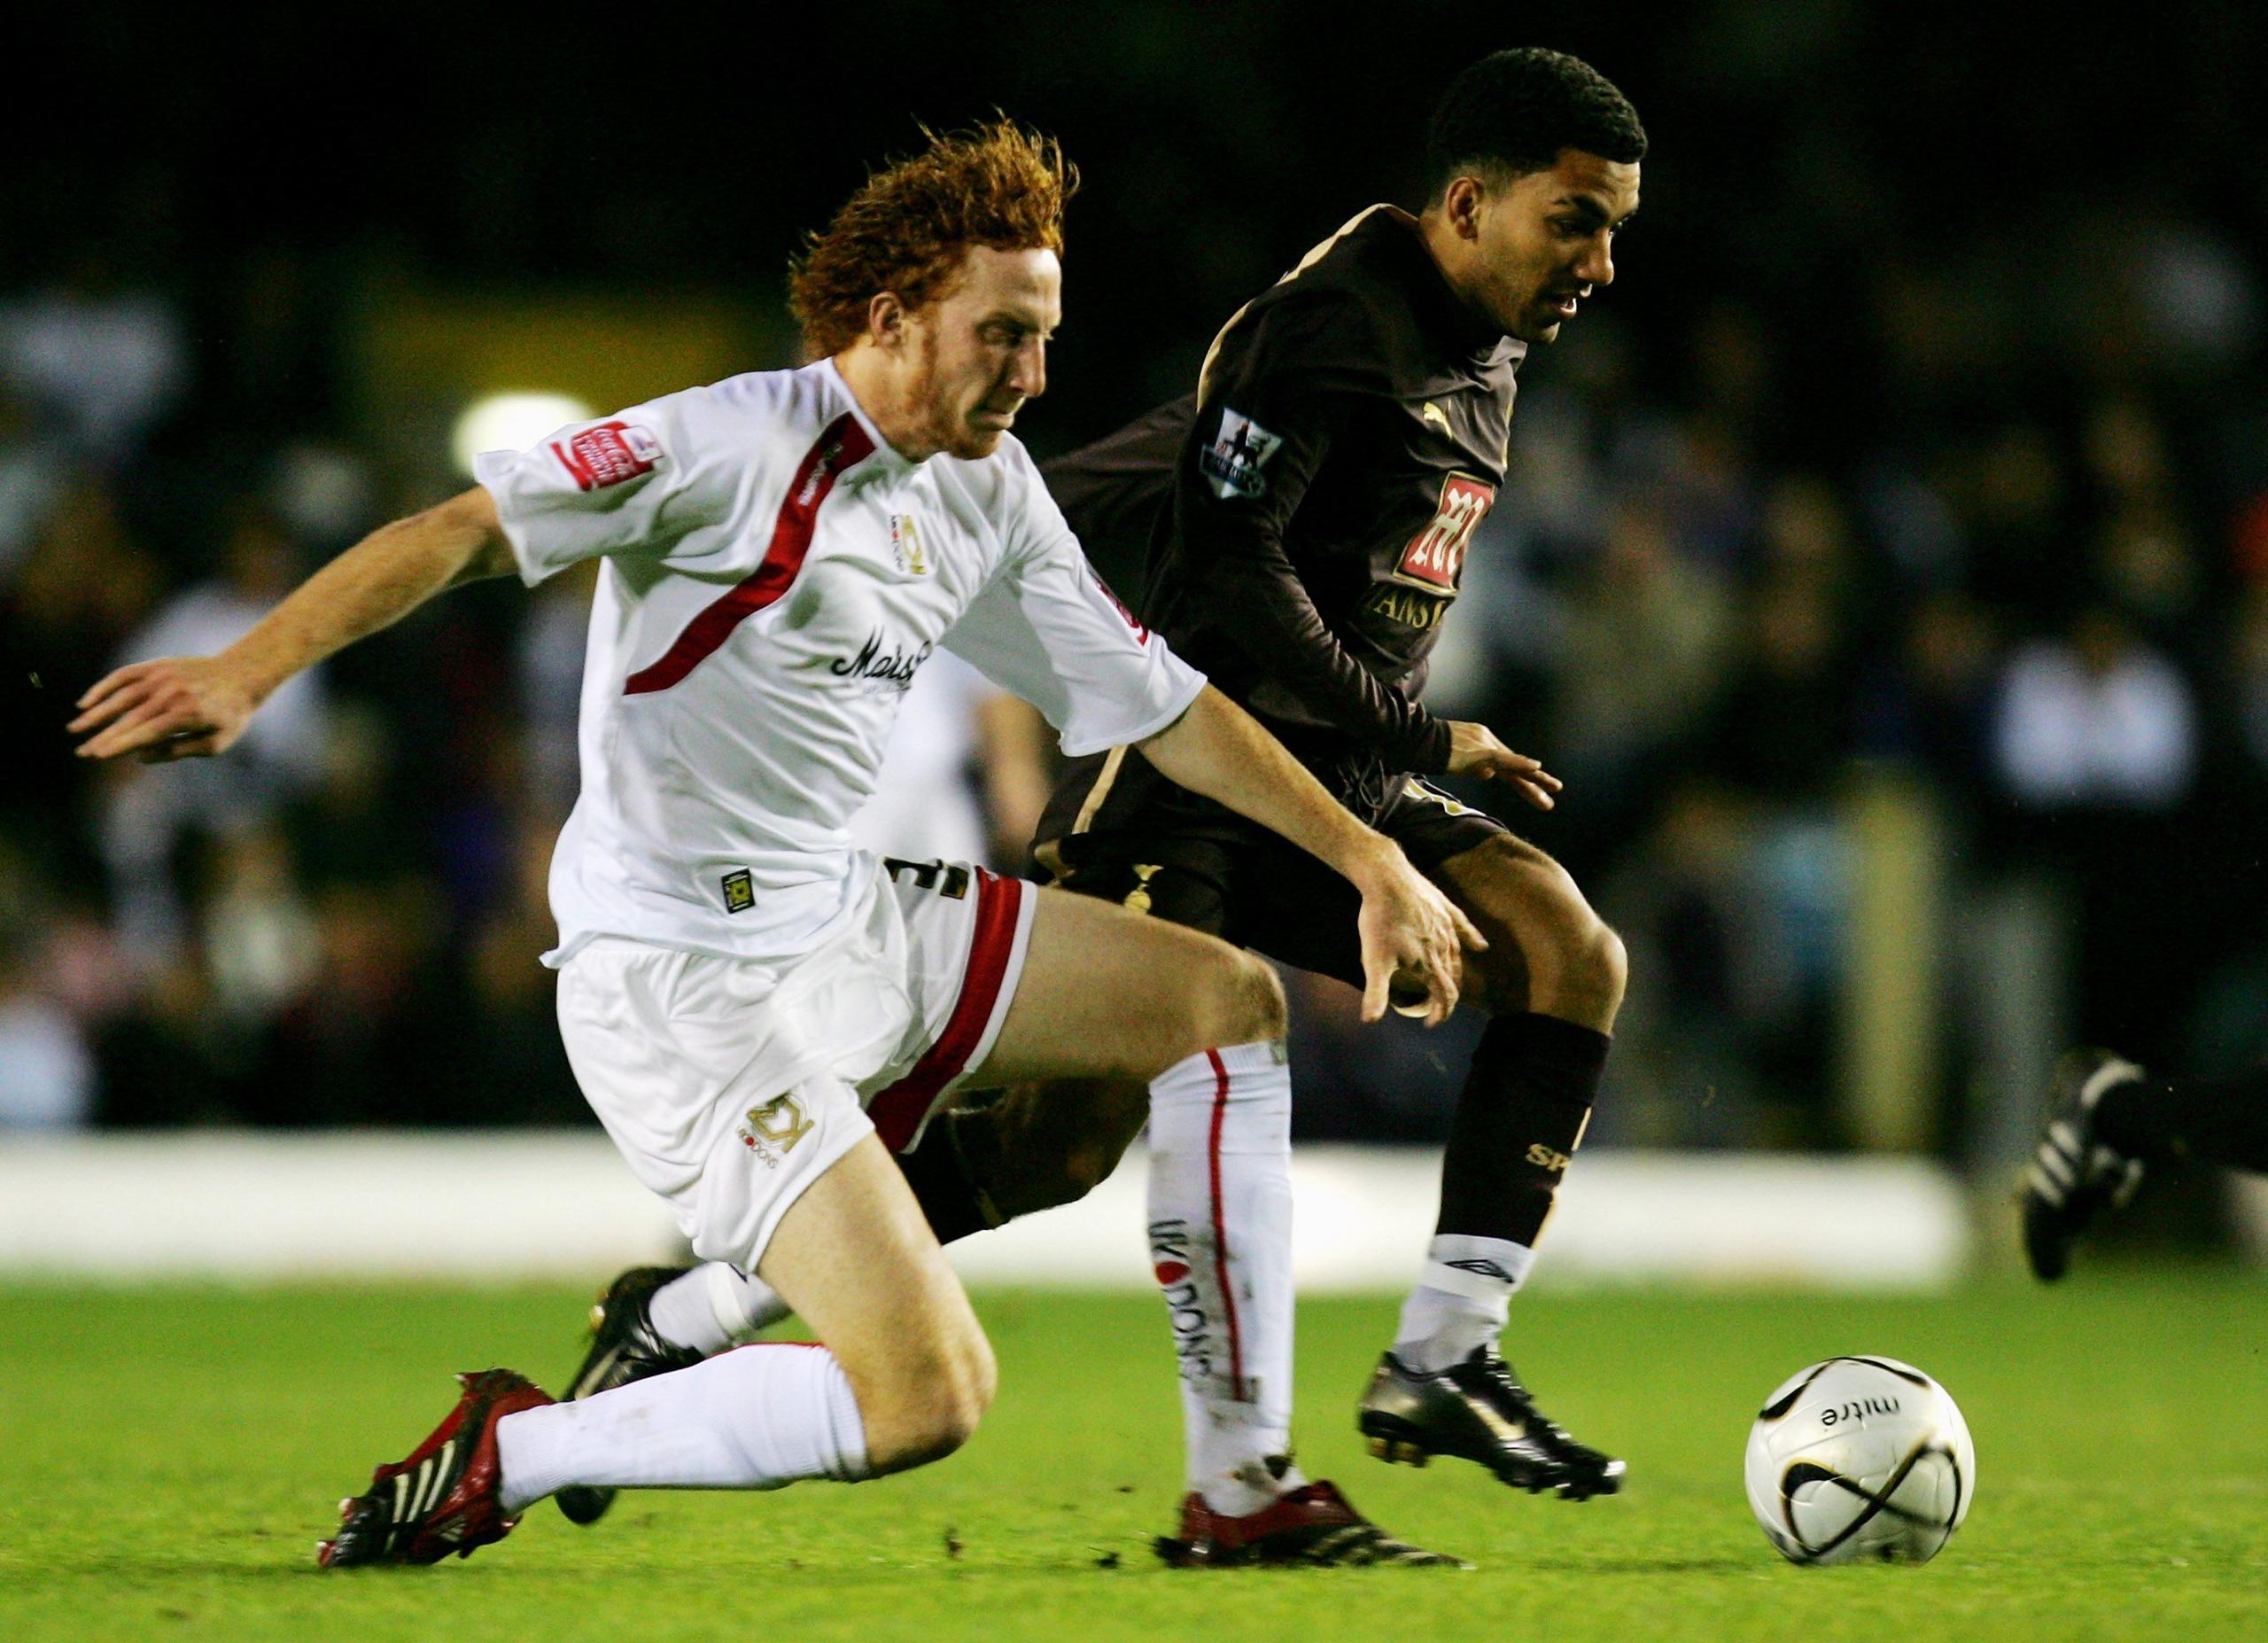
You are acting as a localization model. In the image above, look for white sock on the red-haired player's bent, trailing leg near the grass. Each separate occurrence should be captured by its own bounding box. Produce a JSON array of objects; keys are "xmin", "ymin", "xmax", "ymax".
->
[{"xmin": 497, "ymin": 1343, "xmax": 866, "ymax": 1516}]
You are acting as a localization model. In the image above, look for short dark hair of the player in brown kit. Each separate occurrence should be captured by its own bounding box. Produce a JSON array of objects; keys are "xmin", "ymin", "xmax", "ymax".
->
[{"xmin": 1425, "ymin": 45, "xmax": 1647, "ymax": 199}]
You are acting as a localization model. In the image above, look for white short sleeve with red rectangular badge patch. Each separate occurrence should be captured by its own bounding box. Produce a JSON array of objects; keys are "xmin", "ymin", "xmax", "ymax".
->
[{"xmin": 471, "ymin": 388, "xmax": 734, "ymax": 588}]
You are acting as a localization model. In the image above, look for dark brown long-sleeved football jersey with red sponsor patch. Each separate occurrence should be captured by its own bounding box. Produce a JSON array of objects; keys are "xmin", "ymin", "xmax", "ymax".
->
[{"xmin": 1045, "ymin": 206, "xmax": 1526, "ymax": 772}]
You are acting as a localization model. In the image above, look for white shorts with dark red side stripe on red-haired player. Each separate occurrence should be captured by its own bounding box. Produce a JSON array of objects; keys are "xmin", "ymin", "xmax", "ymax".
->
[{"xmin": 558, "ymin": 862, "xmax": 1038, "ymax": 1271}]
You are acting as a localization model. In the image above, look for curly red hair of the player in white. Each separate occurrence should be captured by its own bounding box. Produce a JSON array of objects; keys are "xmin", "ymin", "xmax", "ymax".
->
[{"xmin": 787, "ymin": 118, "xmax": 1080, "ymax": 359}]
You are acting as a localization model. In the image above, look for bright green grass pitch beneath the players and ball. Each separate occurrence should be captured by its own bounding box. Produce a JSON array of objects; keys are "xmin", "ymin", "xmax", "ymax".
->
[{"xmin": 0, "ymin": 1273, "xmax": 2268, "ymax": 1643}]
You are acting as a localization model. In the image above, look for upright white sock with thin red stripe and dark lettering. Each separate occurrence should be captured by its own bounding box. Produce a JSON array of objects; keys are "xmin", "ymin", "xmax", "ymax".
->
[{"xmin": 1150, "ymin": 1044, "xmax": 1307, "ymax": 1518}]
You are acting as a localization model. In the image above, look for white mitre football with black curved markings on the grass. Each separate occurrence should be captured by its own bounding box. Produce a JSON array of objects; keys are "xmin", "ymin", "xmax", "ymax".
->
[{"xmin": 1749, "ymin": 1357, "xmax": 1977, "ymax": 1563}]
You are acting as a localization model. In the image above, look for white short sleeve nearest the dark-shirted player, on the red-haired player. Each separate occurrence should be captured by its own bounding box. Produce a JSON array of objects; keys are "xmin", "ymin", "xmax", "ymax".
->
[{"xmin": 946, "ymin": 472, "xmax": 1204, "ymax": 758}]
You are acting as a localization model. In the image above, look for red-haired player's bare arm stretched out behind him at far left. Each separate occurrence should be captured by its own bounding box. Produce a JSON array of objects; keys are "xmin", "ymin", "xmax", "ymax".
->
[{"xmin": 70, "ymin": 486, "xmax": 515, "ymax": 762}]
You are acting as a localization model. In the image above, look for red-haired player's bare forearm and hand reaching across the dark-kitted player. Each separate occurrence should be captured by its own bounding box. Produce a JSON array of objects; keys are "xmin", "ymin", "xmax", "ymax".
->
[{"xmin": 1141, "ymin": 685, "xmax": 1487, "ymax": 1025}]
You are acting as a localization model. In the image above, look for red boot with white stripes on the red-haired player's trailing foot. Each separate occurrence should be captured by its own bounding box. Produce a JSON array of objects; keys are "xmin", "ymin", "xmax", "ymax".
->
[{"xmin": 315, "ymin": 1368, "xmax": 551, "ymax": 1568}]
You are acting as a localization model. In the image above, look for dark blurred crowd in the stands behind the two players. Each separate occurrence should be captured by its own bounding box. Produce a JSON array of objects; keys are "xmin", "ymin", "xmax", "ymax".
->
[{"xmin": 0, "ymin": 0, "xmax": 2268, "ymax": 1198}]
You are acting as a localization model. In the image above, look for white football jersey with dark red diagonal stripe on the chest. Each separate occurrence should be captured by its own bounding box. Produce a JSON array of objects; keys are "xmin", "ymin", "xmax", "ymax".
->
[{"xmin": 474, "ymin": 361, "xmax": 1204, "ymax": 964}]
